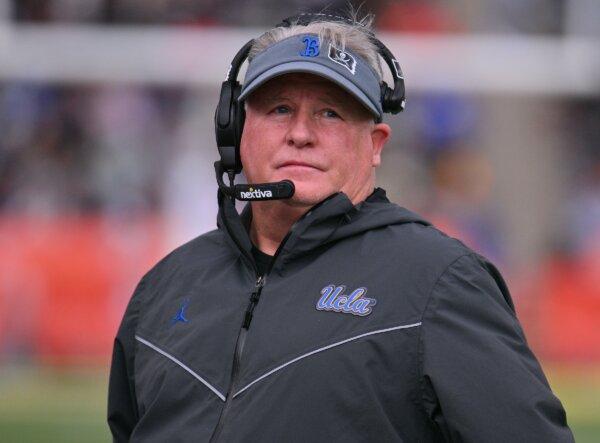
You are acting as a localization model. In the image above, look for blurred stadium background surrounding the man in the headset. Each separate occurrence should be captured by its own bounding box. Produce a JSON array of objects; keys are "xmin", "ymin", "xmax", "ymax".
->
[{"xmin": 0, "ymin": 0, "xmax": 600, "ymax": 442}]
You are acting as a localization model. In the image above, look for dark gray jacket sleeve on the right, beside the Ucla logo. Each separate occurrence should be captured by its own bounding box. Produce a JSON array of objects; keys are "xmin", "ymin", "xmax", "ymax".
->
[{"xmin": 420, "ymin": 253, "xmax": 574, "ymax": 443}]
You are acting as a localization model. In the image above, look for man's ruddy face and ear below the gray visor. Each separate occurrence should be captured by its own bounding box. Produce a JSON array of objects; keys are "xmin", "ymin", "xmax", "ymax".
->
[{"xmin": 240, "ymin": 74, "xmax": 391, "ymax": 206}]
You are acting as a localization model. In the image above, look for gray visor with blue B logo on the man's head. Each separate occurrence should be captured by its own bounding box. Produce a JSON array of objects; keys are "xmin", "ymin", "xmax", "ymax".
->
[{"xmin": 239, "ymin": 34, "xmax": 383, "ymax": 121}]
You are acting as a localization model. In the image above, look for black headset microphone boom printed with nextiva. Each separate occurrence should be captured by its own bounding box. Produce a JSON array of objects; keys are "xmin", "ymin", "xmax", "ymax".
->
[{"xmin": 215, "ymin": 161, "xmax": 296, "ymax": 201}]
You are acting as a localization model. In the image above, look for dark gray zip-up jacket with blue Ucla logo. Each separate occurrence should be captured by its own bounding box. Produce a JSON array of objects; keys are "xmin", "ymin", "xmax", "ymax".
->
[{"xmin": 108, "ymin": 190, "xmax": 573, "ymax": 443}]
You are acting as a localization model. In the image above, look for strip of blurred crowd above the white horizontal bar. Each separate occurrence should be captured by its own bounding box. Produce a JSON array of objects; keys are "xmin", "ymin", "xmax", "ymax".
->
[{"xmin": 13, "ymin": 0, "xmax": 599, "ymax": 34}]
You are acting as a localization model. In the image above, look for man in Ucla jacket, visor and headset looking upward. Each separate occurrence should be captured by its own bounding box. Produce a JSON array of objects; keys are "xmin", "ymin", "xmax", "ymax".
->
[{"xmin": 108, "ymin": 15, "xmax": 573, "ymax": 443}]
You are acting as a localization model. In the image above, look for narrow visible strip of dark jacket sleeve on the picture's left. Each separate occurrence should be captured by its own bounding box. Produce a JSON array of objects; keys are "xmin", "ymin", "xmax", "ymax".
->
[{"xmin": 108, "ymin": 279, "xmax": 145, "ymax": 442}]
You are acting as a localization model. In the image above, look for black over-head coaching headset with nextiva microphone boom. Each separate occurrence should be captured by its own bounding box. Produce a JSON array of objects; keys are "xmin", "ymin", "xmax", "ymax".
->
[{"xmin": 215, "ymin": 13, "xmax": 406, "ymax": 200}]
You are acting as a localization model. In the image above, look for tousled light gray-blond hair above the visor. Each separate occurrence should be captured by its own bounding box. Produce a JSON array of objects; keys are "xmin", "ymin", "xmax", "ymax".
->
[{"xmin": 248, "ymin": 14, "xmax": 383, "ymax": 81}]
